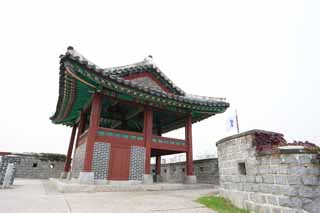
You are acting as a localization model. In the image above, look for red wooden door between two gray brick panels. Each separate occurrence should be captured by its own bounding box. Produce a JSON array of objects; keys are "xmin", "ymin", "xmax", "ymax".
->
[{"xmin": 108, "ymin": 145, "xmax": 130, "ymax": 180}]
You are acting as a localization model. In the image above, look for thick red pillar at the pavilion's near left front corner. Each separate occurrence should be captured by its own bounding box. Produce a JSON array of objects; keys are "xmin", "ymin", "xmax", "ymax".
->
[{"xmin": 83, "ymin": 93, "xmax": 102, "ymax": 172}]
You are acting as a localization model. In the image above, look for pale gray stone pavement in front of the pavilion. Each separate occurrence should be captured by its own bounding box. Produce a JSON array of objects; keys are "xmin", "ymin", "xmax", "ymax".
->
[{"xmin": 0, "ymin": 179, "xmax": 215, "ymax": 213}]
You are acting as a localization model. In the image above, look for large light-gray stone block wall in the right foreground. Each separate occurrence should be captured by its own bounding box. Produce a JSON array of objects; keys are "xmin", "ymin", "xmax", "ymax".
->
[{"xmin": 217, "ymin": 130, "xmax": 320, "ymax": 213}]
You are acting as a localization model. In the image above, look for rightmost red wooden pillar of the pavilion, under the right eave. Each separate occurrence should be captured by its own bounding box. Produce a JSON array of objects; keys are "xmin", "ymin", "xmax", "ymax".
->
[{"xmin": 185, "ymin": 115, "xmax": 193, "ymax": 176}]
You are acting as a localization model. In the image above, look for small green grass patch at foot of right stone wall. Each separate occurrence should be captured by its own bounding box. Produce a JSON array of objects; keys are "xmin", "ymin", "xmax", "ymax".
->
[{"xmin": 197, "ymin": 196, "xmax": 249, "ymax": 213}]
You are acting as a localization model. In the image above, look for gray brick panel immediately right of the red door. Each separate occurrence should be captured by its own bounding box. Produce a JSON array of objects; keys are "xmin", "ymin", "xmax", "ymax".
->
[{"xmin": 129, "ymin": 146, "xmax": 145, "ymax": 180}]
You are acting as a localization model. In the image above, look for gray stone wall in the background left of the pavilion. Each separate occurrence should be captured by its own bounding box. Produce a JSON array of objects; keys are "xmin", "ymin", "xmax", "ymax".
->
[{"xmin": 16, "ymin": 154, "xmax": 65, "ymax": 179}]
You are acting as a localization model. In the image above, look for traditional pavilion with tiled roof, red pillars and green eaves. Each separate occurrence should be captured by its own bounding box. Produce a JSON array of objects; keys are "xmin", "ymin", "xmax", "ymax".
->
[{"xmin": 50, "ymin": 47, "xmax": 229, "ymax": 183}]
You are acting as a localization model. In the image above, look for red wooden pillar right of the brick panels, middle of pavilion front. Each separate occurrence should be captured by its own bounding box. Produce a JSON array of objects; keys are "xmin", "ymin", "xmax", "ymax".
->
[{"xmin": 143, "ymin": 108, "xmax": 153, "ymax": 174}]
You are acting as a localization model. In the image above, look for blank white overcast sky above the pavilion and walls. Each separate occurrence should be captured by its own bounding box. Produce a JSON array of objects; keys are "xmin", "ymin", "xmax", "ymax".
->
[{"xmin": 0, "ymin": 0, "xmax": 320, "ymax": 155}]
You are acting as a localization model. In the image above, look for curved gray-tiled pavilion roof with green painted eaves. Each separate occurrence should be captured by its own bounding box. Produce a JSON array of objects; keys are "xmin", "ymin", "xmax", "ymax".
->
[{"xmin": 50, "ymin": 47, "xmax": 229, "ymax": 131}]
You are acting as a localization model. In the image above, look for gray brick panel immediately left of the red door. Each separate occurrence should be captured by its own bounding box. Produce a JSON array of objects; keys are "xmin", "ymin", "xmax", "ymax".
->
[{"xmin": 92, "ymin": 142, "xmax": 110, "ymax": 180}]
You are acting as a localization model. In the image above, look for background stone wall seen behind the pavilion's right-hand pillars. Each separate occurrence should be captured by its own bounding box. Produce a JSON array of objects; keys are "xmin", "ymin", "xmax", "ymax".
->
[{"xmin": 152, "ymin": 158, "xmax": 219, "ymax": 184}]
